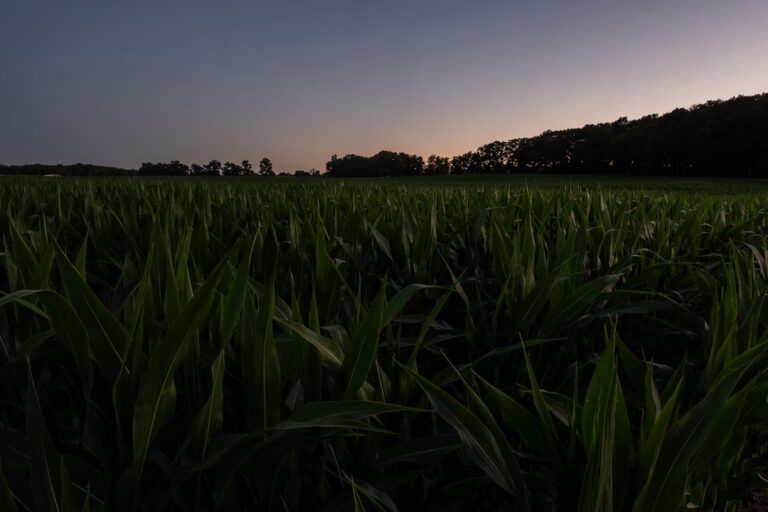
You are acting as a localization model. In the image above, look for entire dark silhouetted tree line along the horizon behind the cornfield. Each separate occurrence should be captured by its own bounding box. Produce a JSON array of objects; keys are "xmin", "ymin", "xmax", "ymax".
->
[{"xmin": 0, "ymin": 93, "xmax": 768, "ymax": 178}]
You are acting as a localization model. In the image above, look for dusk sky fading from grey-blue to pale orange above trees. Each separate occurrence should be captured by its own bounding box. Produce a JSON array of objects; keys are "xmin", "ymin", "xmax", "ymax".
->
[{"xmin": 0, "ymin": 0, "xmax": 768, "ymax": 171}]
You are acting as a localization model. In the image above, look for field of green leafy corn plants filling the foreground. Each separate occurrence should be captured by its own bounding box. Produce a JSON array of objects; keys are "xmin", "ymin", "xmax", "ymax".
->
[{"xmin": 0, "ymin": 178, "xmax": 768, "ymax": 512}]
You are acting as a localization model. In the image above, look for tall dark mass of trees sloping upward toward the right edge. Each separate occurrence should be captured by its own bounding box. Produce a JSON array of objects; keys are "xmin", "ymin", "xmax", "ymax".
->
[{"xmin": 450, "ymin": 94, "xmax": 768, "ymax": 177}]
